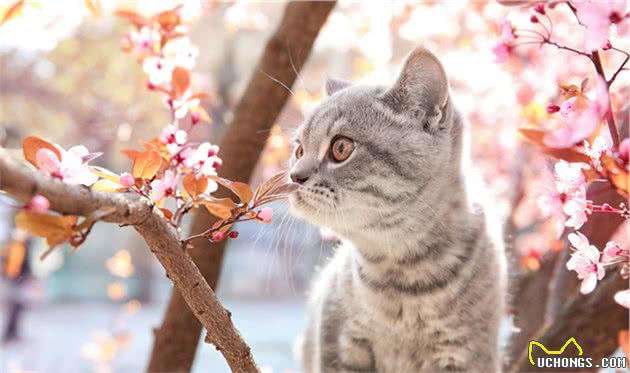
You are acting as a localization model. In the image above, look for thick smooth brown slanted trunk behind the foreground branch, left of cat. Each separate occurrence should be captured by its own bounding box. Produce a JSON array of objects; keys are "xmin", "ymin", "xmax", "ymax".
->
[{"xmin": 148, "ymin": 2, "xmax": 335, "ymax": 372}]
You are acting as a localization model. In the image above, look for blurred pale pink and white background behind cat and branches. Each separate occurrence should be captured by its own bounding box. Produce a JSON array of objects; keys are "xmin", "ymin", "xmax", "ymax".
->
[{"xmin": 0, "ymin": 0, "xmax": 630, "ymax": 373}]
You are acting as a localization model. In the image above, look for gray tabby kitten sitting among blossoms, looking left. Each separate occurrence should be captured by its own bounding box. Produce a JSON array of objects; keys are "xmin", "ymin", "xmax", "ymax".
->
[{"xmin": 290, "ymin": 48, "xmax": 506, "ymax": 373}]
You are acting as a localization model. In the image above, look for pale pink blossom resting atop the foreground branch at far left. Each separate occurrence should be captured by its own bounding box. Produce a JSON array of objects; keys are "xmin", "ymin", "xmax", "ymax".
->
[{"xmin": 35, "ymin": 145, "xmax": 98, "ymax": 186}]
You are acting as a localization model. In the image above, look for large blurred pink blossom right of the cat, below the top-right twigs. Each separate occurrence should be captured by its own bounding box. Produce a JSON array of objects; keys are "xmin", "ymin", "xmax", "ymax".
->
[{"xmin": 543, "ymin": 77, "xmax": 609, "ymax": 148}]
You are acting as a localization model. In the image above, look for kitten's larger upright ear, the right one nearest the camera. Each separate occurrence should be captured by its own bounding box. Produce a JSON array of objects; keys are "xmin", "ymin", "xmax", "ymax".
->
[{"xmin": 384, "ymin": 47, "xmax": 448, "ymax": 126}]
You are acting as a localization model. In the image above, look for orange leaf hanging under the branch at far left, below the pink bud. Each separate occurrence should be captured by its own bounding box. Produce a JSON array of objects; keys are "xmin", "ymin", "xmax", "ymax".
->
[{"xmin": 15, "ymin": 211, "xmax": 78, "ymax": 247}]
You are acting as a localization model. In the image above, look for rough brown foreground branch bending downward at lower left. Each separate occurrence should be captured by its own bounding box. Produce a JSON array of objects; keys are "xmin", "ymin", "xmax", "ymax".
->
[{"xmin": 0, "ymin": 149, "xmax": 258, "ymax": 372}]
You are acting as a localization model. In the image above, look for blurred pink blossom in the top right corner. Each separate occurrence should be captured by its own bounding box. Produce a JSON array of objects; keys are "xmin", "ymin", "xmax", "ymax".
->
[{"xmin": 572, "ymin": 0, "xmax": 627, "ymax": 51}]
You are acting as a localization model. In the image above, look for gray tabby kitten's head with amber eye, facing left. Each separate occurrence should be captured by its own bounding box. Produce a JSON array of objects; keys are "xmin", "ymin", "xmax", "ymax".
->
[{"xmin": 289, "ymin": 48, "xmax": 460, "ymax": 234}]
